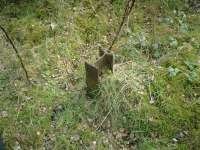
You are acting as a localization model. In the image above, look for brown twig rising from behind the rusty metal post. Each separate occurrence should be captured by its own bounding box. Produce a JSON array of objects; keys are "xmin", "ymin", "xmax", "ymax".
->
[{"xmin": 108, "ymin": 0, "xmax": 136, "ymax": 51}]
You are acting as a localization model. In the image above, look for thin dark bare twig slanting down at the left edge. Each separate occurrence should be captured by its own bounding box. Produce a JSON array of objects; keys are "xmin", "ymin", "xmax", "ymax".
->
[{"xmin": 0, "ymin": 25, "xmax": 31, "ymax": 84}]
